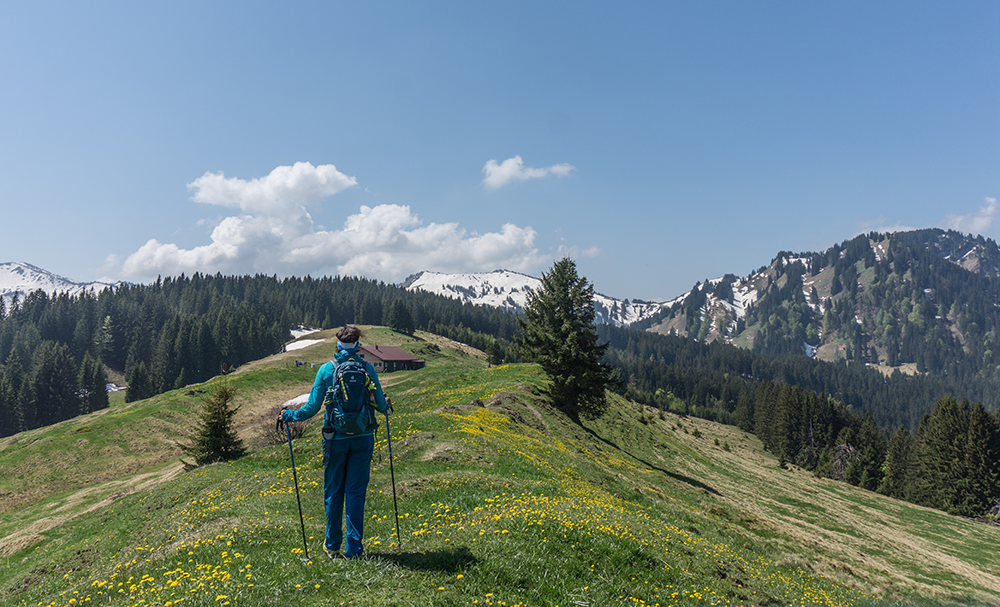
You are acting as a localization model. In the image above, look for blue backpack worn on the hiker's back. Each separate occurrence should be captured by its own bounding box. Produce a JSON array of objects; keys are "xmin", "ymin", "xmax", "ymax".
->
[{"xmin": 323, "ymin": 354, "xmax": 378, "ymax": 437}]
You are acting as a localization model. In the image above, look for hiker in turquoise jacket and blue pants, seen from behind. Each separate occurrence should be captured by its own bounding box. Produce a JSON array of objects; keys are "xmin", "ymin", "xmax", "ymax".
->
[{"xmin": 278, "ymin": 325, "xmax": 392, "ymax": 559}]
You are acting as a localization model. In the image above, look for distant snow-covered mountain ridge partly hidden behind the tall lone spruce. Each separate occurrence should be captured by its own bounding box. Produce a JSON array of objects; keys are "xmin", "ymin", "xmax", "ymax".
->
[{"xmin": 403, "ymin": 270, "xmax": 662, "ymax": 326}]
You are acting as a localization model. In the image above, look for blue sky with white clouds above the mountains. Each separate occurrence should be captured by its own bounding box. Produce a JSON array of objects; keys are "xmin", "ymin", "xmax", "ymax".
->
[{"xmin": 0, "ymin": 2, "xmax": 1000, "ymax": 299}]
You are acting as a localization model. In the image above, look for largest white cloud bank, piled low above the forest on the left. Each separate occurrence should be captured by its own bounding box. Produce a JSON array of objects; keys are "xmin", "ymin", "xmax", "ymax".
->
[{"xmin": 122, "ymin": 162, "xmax": 546, "ymax": 282}]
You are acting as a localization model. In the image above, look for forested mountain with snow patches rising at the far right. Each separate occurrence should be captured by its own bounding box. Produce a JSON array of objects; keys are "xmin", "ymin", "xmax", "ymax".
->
[{"xmin": 647, "ymin": 229, "xmax": 1000, "ymax": 376}]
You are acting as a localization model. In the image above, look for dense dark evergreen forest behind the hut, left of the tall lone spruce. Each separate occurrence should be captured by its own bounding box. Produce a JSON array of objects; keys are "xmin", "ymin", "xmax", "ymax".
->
[{"xmin": 0, "ymin": 273, "xmax": 517, "ymax": 436}]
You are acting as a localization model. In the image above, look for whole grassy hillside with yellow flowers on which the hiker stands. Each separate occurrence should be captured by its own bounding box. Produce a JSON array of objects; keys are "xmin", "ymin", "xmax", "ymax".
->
[{"xmin": 0, "ymin": 329, "xmax": 1000, "ymax": 606}]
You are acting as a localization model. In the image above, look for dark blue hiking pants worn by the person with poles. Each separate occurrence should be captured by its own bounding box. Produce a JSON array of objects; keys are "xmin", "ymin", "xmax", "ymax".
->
[{"xmin": 323, "ymin": 434, "xmax": 375, "ymax": 557}]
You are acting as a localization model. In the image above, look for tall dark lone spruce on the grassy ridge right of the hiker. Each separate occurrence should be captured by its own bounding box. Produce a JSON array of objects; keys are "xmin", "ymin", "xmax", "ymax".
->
[{"xmin": 517, "ymin": 259, "xmax": 611, "ymax": 421}]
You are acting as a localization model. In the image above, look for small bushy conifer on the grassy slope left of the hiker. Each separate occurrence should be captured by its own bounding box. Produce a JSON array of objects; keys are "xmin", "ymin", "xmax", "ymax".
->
[{"xmin": 181, "ymin": 383, "xmax": 246, "ymax": 470}]
